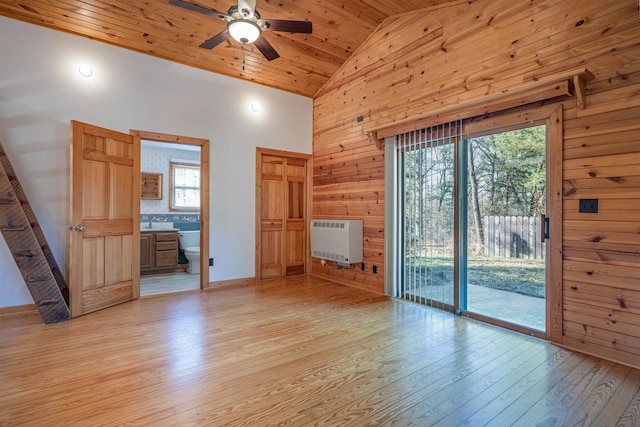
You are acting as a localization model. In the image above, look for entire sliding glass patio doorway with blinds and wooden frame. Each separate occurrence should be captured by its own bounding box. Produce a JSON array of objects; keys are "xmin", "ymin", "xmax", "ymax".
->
[{"xmin": 386, "ymin": 105, "xmax": 562, "ymax": 340}]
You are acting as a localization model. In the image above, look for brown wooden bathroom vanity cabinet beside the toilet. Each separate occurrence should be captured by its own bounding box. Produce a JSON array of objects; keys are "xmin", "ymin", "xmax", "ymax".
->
[{"xmin": 140, "ymin": 230, "xmax": 178, "ymax": 275}]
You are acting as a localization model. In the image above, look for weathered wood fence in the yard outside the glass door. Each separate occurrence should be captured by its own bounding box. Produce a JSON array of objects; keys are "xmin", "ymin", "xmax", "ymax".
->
[{"xmin": 482, "ymin": 216, "xmax": 546, "ymax": 259}]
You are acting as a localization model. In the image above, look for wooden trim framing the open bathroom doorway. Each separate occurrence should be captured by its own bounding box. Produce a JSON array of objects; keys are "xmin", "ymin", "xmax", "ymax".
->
[{"xmin": 129, "ymin": 129, "xmax": 211, "ymax": 291}]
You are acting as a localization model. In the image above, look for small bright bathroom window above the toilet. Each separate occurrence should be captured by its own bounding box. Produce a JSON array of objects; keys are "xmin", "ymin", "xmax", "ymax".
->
[{"xmin": 170, "ymin": 162, "xmax": 200, "ymax": 212}]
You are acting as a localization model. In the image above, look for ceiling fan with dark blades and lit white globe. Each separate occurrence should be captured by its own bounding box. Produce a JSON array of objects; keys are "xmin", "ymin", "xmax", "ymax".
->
[{"xmin": 169, "ymin": 0, "xmax": 312, "ymax": 61}]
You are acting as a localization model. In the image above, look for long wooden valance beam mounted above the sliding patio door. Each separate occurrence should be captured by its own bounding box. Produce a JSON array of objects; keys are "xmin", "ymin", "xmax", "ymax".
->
[{"xmin": 376, "ymin": 73, "xmax": 580, "ymax": 138}]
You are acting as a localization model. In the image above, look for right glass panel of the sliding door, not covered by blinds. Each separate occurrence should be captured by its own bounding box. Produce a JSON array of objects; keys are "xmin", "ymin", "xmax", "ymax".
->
[{"xmin": 460, "ymin": 125, "xmax": 546, "ymax": 331}]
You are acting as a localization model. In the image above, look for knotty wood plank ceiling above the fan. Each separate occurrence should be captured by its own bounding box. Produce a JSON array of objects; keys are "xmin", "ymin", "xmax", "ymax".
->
[{"xmin": 0, "ymin": 0, "xmax": 458, "ymax": 97}]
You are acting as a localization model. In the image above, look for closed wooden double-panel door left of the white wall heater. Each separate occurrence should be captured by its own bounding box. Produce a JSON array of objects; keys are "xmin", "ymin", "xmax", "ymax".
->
[{"xmin": 256, "ymin": 149, "xmax": 309, "ymax": 280}]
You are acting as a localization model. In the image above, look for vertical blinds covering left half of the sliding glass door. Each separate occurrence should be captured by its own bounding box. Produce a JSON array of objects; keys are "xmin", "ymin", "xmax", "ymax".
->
[{"xmin": 395, "ymin": 122, "xmax": 461, "ymax": 310}]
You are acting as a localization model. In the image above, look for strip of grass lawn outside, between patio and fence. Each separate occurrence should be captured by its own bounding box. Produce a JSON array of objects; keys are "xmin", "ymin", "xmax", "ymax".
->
[{"xmin": 407, "ymin": 256, "xmax": 545, "ymax": 298}]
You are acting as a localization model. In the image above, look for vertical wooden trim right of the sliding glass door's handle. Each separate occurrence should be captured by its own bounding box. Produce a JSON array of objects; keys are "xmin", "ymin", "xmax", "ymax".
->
[{"xmin": 546, "ymin": 104, "xmax": 563, "ymax": 343}]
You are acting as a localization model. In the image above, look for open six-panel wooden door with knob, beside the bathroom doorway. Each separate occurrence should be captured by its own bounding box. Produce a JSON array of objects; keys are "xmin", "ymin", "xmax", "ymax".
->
[{"xmin": 69, "ymin": 121, "xmax": 140, "ymax": 317}]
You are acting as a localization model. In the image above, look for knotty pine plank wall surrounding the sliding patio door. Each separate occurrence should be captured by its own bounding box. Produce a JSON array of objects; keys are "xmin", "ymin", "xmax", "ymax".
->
[{"xmin": 312, "ymin": 0, "xmax": 640, "ymax": 366}]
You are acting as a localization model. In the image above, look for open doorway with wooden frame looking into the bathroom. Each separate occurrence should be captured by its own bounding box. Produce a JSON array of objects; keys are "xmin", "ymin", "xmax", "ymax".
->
[{"xmin": 131, "ymin": 131, "xmax": 209, "ymax": 296}]
